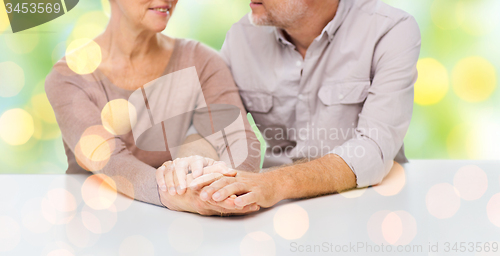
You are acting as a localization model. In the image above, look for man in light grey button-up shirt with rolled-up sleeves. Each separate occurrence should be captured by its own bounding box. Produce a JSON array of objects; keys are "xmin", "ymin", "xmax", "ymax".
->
[{"xmin": 158, "ymin": 0, "xmax": 420, "ymax": 213}]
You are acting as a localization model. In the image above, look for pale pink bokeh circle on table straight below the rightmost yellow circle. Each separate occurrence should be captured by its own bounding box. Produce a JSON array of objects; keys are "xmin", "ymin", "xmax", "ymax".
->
[{"xmin": 453, "ymin": 165, "xmax": 488, "ymax": 201}]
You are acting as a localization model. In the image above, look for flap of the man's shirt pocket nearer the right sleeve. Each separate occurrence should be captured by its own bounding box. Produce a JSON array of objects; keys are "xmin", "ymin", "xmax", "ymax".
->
[{"xmin": 318, "ymin": 81, "xmax": 370, "ymax": 106}]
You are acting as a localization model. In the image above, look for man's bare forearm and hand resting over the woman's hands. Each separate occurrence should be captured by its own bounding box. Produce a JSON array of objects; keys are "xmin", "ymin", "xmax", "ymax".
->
[{"xmin": 200, "ymin": 154, "xmax": 356, "ymax": 209}]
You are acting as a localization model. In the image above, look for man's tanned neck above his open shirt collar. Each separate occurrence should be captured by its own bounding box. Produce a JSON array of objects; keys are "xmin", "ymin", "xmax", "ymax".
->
[{"xmin": 283, "ymin": 0, "xmax": 339, "ymax": 58}]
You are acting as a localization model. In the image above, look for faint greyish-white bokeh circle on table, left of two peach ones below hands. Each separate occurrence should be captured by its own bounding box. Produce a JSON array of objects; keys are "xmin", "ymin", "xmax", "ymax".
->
[{"xmin": 168, "ymin": 216, "xmax": 205, "ymax": 253}]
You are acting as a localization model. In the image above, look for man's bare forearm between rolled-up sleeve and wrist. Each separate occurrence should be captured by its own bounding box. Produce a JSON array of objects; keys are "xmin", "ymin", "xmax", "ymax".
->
[{"xmin": 272, "ymin": 154, "xmax": 356, "ymax": 200}]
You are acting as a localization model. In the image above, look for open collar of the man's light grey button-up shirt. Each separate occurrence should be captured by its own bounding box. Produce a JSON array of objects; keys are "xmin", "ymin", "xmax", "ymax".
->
[{"xmin": 274, "ymin": 0, "xmax": 354, "ymax": 46}]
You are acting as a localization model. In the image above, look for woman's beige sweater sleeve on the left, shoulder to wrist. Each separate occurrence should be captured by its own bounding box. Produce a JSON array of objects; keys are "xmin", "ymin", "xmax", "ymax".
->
[{"xmin": 45, "ymin": 61, "xmax": 163, "ymax": 206}]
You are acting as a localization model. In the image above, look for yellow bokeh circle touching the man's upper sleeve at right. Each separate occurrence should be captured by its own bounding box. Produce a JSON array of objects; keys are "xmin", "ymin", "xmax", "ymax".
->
[{"xmin": 415, "ymin": 58, "xmax": 449, "ymax": 106}]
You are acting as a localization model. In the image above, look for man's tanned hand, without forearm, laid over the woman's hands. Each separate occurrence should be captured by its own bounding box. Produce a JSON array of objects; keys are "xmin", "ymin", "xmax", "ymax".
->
[{"xmin": 200, "ymin": 172, "xmax": 283, "ymax": 209}]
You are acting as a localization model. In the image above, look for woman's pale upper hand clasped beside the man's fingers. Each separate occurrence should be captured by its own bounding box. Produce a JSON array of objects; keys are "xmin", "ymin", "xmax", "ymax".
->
[{"xmin": 156, "ymin": 156, "xmax": 236, "ymax": 195}]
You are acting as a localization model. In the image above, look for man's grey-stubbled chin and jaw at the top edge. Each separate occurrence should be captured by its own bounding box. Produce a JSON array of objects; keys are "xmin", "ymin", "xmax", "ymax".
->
[{"xmin": 248, "ymin": 0, "xmax": 307, "ymax": 28}]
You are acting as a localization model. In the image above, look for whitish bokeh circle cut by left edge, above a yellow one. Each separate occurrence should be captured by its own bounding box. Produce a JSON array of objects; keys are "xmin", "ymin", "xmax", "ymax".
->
[{"xmin": 0, "ymin": 61, "xmax": 25, "ymax": 98}]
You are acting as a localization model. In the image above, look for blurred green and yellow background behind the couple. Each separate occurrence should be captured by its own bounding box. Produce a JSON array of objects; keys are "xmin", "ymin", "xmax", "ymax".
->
[{"xmin": 0, "ymin": 0, "xmax": 500, "ymax": 173}]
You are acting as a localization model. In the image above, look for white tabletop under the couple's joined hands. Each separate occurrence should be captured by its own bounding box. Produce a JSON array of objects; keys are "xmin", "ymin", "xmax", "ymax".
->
[{"xmin": 0, "ymin": 160, "xmax": 500, "ymax": 255}]
